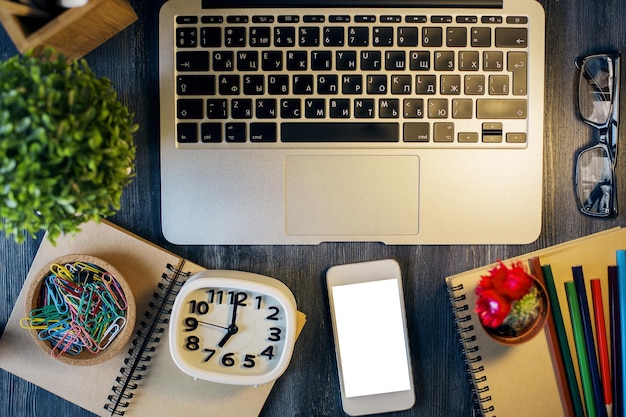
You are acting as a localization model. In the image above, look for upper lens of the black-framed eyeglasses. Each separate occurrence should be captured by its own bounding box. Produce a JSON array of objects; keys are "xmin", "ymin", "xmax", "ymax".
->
[{"xmin": 578, "ymin": 56, "xmax": 613, "ymax": 126}]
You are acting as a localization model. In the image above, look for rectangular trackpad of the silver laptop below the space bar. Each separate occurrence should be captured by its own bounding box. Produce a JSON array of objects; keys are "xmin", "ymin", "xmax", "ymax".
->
[{"xmin": 285, "ymin": 155, "xmax": 419, "ymax": 235}]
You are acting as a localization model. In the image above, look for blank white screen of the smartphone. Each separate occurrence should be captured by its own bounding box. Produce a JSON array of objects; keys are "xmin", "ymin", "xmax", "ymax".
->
[{"xmin": 332, "ymin": 279, "xmax": 411, "ymax": 398}]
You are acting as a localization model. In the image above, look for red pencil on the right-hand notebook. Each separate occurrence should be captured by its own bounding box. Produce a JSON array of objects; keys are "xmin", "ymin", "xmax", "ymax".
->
[{"xmin": 591, "ymin": 279, "xmax": 613, "ymax": 417}]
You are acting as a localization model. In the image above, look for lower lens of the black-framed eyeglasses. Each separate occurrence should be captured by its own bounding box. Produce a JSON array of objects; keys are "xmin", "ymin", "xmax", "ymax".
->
[{"xmin": 576, "ymin": 144, "xmax": 615, "ymax": 216}]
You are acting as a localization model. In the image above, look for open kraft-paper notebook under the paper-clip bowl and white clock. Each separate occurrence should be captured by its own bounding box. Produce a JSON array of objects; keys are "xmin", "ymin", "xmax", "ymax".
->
[{"xmin": 0, "ymin": 221, "xmax": 304, "ymax": 417}]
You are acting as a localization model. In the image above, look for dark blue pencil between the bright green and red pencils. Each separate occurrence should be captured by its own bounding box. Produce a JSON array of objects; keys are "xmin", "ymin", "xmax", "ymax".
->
[{"xmin": 572, "ymin": 265, "xmax": 608, "ymax": 417}]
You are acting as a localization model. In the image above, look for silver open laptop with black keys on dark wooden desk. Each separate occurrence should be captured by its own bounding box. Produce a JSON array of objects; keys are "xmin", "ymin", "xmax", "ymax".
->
[{"xmin": 159, "ymin": 0, "xmax": 545, "ymax": 245}]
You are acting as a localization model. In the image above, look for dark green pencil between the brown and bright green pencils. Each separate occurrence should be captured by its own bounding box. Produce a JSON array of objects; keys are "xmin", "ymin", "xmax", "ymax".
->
[{"xmin": 541, "ymin": 265, "xmax": 585, "ymax": 417}]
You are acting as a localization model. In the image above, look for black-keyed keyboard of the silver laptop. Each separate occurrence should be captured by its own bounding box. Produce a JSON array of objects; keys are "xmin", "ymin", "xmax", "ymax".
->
[{"xmin": 173, "ymin": 8, "xmax": 529, "ymax": 148}]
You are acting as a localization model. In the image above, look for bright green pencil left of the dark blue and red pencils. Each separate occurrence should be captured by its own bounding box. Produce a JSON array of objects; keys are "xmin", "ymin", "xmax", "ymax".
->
[{"xmin": 565, "ymin": 281, "xmax": 597, "ymax": 417}]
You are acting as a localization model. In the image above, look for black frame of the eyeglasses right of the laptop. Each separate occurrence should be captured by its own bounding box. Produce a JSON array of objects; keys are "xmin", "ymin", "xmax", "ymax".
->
[{"xmin": 574, "ymin": 52, "xmax": 620, "ymax": 217}]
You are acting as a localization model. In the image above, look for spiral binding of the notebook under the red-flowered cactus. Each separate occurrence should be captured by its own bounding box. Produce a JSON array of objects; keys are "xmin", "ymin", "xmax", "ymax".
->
[{"xmin": 448, "ymin": 284, "xmax": 495, "ymax": 417}]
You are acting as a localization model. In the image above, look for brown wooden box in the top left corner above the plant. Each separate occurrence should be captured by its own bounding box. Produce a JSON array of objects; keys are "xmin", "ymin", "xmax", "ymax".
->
[{"xmin": 0, "ymin": 0, "xmax": 137, "ymax": 59}]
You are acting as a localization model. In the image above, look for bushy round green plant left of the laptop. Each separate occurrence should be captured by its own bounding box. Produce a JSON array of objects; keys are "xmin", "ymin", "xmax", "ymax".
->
[{"xmin": 0, "ymin": 49, "xmax": 138, "ymax": 242}]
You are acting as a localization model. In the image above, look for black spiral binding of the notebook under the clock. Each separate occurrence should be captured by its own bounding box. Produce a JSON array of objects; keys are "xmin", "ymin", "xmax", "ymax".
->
[{"xmin": 104, "ymin": 260, "xmax": 190, "ymax": 416}]
